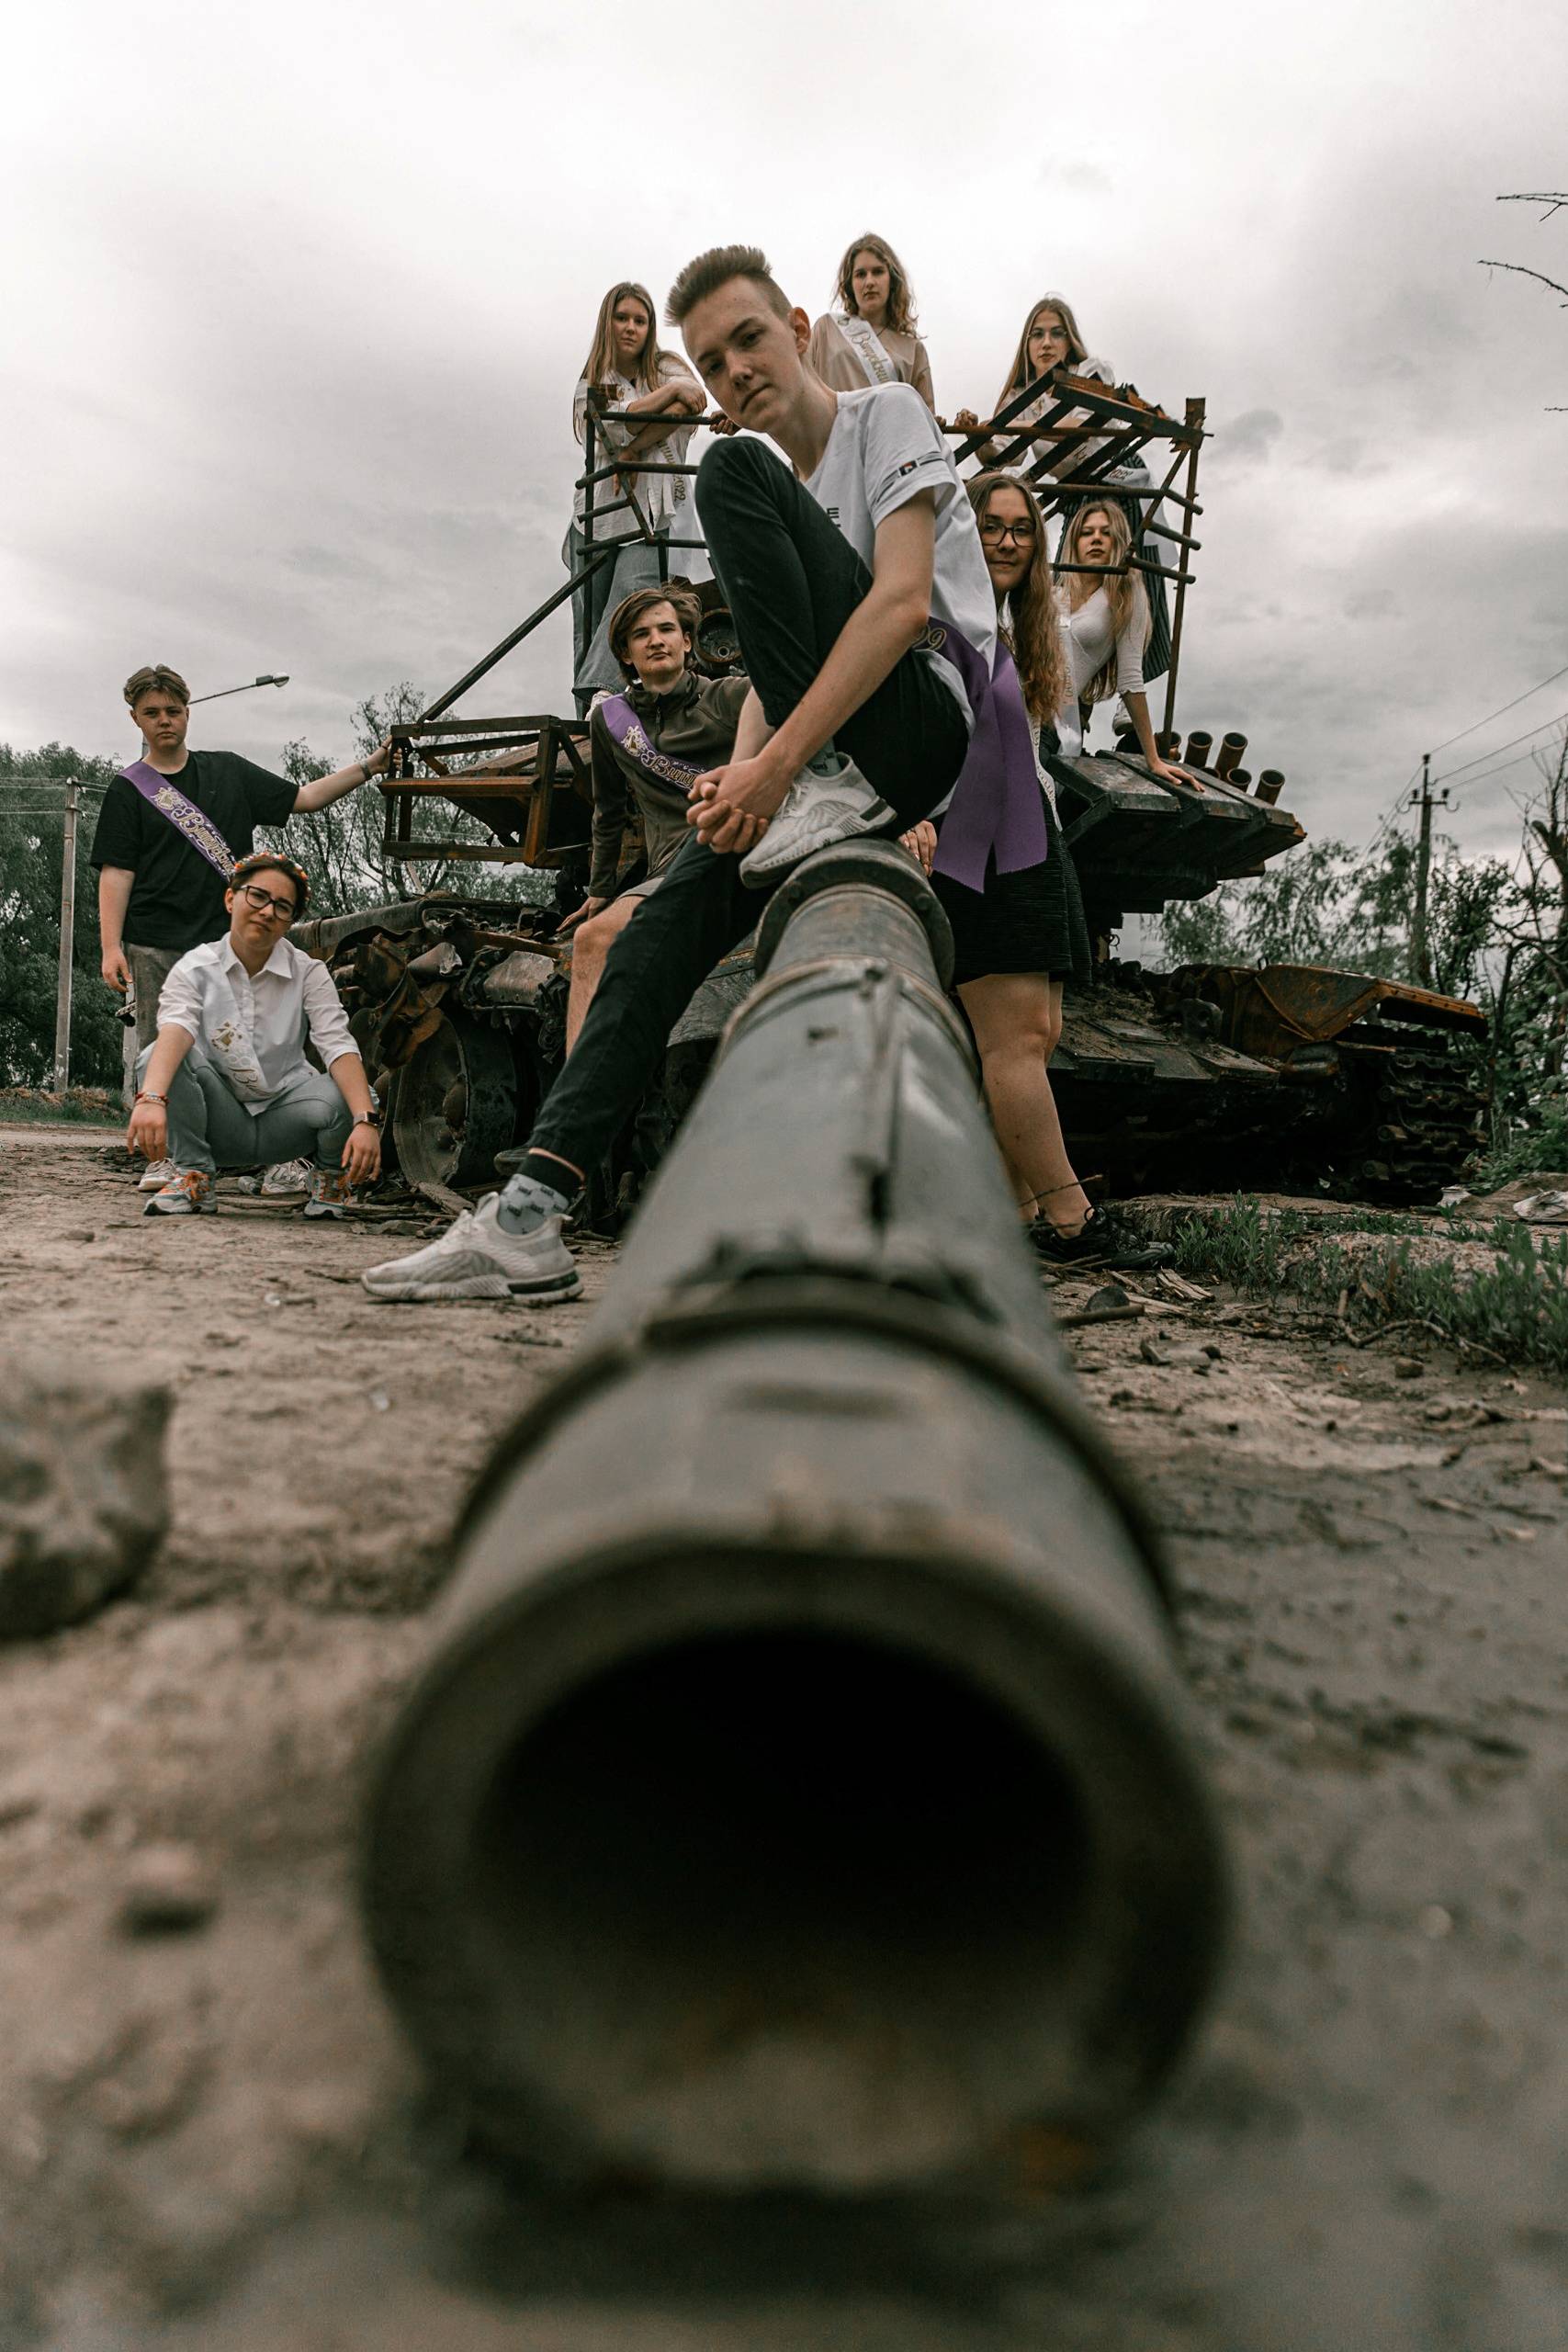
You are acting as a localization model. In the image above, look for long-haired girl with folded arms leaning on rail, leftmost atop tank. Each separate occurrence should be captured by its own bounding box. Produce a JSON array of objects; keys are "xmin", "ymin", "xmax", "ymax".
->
[{"xmin": 562, "ymin": 277, "xmax": 707, "ymax": 701}]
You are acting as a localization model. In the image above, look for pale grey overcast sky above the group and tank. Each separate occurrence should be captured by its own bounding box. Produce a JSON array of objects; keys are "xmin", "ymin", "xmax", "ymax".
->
[{"xmin": 0, "ymin": 0, "xmax": 1568, "ymax": 849}]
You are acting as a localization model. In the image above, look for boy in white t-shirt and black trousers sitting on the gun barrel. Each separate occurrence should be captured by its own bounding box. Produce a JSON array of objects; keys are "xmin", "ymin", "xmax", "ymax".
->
[{"xmin": 365, "ymin": 244, "xmax": 1020, "ymax": 1303}]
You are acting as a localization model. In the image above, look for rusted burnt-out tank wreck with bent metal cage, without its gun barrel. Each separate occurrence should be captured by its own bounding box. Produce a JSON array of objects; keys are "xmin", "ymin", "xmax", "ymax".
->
[{"xmin": 296, "ymin": 371, "xmax": 1483, "ymax": 1223}]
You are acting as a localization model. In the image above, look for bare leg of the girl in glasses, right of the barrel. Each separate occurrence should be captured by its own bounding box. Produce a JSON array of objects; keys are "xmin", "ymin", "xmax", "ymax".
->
[{"xmin": 959, "ymin": 971, "xmax": 1089, "ymax": 1235}]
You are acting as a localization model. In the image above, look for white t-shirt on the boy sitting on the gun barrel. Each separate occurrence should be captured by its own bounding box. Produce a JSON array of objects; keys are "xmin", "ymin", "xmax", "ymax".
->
[{"xmin": 807, "ymin": 383, "xmax": 997, "ymax": 731}]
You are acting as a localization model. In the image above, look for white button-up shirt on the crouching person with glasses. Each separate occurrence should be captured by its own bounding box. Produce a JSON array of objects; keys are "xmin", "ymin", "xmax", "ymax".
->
[{"xmin": 157, "ymin": 938, "xmax": 360, "ymax": 1110}]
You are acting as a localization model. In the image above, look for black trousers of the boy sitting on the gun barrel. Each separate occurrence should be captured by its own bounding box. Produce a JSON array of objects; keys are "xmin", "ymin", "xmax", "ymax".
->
[{"xmin": 529, "ymin": 440, "xmax": 968, "ymax": 1169}]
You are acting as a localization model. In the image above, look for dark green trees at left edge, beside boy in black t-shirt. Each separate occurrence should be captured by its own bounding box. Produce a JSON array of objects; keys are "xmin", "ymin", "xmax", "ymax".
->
[{"xmin": 0, "ymin": 743, "xmax": 122, "ymax": 1087}]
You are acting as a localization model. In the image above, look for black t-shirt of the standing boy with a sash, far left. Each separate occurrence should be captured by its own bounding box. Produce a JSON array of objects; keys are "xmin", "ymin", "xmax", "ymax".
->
[{"xmin": 92, "ymin": 751, "xmax": 299, "ymax": 955}]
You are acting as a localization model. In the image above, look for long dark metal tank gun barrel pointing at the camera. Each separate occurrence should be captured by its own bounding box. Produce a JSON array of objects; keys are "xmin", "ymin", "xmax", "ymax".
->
[{"xmin": 365, "ymin": 844, "xmax": 1227, "ymax": 2189}]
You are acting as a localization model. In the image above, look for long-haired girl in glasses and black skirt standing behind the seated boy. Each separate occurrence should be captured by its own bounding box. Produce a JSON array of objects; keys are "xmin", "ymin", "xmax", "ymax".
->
[{"xmin": 931, "ymin": 473, "xmax": 1126, "ymax": 1265}]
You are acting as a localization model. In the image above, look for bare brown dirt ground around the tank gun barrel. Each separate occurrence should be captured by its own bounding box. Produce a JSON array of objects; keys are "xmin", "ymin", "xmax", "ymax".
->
[{"xmin": 0, "ymin": 1129, "xmax": 1568, "ymax": 2352}]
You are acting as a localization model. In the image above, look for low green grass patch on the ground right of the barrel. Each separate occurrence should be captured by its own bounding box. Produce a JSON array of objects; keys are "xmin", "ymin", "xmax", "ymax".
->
[{"xmin": 1176, "ymin": 1194, "xmax": 1568, "ymax": 1371}]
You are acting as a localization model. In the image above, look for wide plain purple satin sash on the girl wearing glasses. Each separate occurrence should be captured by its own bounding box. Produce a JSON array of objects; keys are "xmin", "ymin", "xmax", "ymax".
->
[{"xmin": 919, "ymin": 621, "xmax": 1048, "ymax": 891}]
